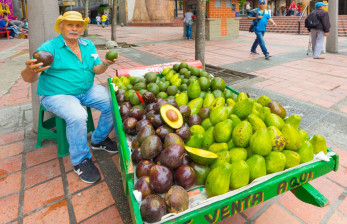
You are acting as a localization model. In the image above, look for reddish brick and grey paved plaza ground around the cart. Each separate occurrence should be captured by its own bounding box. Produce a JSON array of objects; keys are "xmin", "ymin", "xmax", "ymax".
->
[{"xmin": 0, "ymin": 25, "xmax": 347, "ymax": 224}]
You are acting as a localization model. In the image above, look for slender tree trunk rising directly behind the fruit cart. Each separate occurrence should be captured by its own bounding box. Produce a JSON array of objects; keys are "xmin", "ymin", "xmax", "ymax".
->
[{"xmin": 195, "ymin": 0, "xmax": 206, "ymax": 69}]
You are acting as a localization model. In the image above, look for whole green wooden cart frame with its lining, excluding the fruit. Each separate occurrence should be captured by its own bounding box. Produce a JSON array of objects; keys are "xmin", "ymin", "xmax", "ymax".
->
[{"xmin": 108, "ymin": 62, "xmax": 339, "ymax": 224}]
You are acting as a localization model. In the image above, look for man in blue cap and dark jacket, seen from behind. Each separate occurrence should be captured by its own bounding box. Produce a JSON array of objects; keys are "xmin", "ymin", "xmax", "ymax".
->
[{"xmin": 305, "ymin": 2, "xmax": 330, "ymax": 59}]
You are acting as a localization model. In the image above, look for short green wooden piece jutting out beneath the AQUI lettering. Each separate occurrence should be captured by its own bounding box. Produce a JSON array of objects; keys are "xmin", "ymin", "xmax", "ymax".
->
[{"xmin": 292, "ymin": 183, "xmax": 329, "ymax": 207}]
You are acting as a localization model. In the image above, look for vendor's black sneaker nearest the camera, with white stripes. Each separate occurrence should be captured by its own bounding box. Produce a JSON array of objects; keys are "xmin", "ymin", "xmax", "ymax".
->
[{"xmin": 73, "ymin": 159, "xmax": 101, "ymax": 184}]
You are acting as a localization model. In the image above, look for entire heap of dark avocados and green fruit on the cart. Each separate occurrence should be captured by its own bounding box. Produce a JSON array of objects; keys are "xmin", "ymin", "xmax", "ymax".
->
[{"xmin": 113, "ymin": 62, "xmax": 327, "ymax": 221}]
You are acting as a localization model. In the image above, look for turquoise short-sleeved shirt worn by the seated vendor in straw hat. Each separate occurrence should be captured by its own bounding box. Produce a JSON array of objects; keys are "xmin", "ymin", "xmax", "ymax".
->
[{"xmin": 37, "ymin": 34, "xmax": 101, "ymax": 95}]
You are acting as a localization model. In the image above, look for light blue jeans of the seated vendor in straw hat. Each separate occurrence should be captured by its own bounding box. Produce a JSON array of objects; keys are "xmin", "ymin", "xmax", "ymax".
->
[{"xmin": 40, "ymin": 85, "xmax": 113, "ymax": 166}]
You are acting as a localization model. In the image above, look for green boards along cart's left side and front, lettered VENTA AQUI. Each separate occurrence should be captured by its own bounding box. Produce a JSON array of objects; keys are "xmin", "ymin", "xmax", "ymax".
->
[{"xmin": 108, "ymin": 78, "xmax": 338, "ymax": 224}]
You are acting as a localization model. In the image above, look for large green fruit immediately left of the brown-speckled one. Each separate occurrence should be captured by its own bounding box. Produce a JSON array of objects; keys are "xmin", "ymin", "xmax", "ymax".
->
[{"xmin": 250, "ymin": 128, "xmax": 272, "ymax": 156}]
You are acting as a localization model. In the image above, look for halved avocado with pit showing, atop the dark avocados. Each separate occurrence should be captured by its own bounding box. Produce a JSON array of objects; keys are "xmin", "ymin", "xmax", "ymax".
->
[{"xmin": 160, "ymin": 104, "xmax": 183, "ymax": 129}]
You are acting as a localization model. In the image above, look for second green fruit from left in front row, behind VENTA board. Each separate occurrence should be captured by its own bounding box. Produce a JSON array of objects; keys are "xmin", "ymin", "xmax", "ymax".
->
[{"xmin": 230, "ymin": 160, "xmax": 250, "ymax": 190}]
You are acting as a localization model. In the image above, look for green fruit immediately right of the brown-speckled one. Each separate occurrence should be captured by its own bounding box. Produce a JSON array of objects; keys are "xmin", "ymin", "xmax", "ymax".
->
[{"xmin": 282, "ymin": 124, "xmax": 302, "ymax": 151}]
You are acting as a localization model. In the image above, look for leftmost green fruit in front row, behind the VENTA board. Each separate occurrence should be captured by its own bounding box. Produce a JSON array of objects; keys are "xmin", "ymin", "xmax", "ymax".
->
[{"xmin": 205, "ymin": 163, "xmax": 231, "ymax": 197}]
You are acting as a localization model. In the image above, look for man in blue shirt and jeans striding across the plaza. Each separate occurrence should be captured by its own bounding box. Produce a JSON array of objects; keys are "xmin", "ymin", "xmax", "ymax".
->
[{"xmin": 248, "ymin": 0, "xmax": 276, "ymax": 59}]
